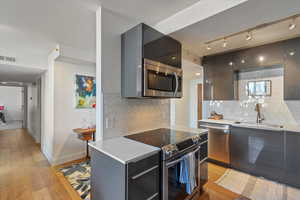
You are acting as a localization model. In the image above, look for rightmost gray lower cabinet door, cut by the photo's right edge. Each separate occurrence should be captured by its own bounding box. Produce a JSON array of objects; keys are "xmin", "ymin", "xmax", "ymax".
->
[{"xmin": 284, "ymin": 131, "xmax": 300, "ymax": 188}]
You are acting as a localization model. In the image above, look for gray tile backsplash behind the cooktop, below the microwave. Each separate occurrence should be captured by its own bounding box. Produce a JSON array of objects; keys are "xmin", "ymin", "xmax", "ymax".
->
[{"xmin": 103, "ymin": 93, "xmax": 170, "ymax": 139}]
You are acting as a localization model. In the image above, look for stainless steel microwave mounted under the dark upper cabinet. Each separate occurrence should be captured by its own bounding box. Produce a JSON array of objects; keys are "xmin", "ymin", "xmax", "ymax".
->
[{"xmin": 143, "ymin": 59, "xmax": 182, "ymax": 98}]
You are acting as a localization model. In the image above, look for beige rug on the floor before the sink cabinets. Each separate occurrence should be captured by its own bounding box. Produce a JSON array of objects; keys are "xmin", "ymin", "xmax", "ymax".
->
[{"xmin": 215, "ymin": 169, "xmax": 300, "ymax": 200}]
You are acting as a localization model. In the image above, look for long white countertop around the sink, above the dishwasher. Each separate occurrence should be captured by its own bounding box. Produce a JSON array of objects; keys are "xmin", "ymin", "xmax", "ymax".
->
[{"xmin": 199, "ymin": 119, "xmax": 300, "ymax": 133}]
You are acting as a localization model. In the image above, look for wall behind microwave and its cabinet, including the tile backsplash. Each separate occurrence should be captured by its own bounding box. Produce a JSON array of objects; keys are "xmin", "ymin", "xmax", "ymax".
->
[{"xmin": 101, "ymin": 8, "xmax": 170, "ymax": 139}]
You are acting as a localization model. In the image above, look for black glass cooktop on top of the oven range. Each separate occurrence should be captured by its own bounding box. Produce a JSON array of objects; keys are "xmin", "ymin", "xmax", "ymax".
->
[{"xmin": 125, "ymin": 128, "xmax": 197, "ymax": 148}]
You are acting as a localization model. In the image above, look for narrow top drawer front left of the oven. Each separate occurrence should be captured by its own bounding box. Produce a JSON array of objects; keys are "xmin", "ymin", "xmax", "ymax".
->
[{"xmin": 128, "ymin": 153, "xmax": 160, "ymax": 177}]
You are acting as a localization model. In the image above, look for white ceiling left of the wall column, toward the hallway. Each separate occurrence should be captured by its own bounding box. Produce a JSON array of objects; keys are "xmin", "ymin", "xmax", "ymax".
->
[{"xmin": 0, "ymin": 0, "xmax": 99, "ymax": 55}]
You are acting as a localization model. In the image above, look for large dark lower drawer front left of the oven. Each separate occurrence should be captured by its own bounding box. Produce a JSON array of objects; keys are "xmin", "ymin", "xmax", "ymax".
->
[{"xmin": 128, "ymin": 168, "xmax": 160, "ymax": 200}]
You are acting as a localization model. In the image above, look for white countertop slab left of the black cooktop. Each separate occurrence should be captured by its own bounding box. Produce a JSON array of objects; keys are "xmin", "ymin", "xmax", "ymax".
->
[{"xmin": 89, "ymin": 137, "xmax": 160, "ymax": 164}]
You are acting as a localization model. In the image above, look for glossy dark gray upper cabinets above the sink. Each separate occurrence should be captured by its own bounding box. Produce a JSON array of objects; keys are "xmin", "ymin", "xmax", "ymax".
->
[{"xmin": 202, "ymin": 37, "xmax": 300, "ymax": 100}]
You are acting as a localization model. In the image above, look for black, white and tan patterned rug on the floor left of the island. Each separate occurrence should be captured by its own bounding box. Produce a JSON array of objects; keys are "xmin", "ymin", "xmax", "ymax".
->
[{"xmin": 59, "ymin": 161, "xmax": 91, "ymax": 200}]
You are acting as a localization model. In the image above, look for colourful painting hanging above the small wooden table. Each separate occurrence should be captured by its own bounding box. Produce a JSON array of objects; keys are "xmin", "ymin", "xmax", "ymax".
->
[{"xmin": 75, "ymin": 75, "xmax": 96, "ymax": 108}]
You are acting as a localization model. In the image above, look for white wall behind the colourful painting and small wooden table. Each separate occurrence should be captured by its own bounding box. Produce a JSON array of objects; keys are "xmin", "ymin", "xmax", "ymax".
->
[{"xmin": 52, "ymin": 62, "xmax": 96, "ymax": 164}]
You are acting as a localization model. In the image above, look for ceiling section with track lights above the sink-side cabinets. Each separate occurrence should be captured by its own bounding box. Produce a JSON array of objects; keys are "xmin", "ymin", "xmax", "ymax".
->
[{"xmin": 171, "ymin": 0, "xmax": 300, "ymax": 56}]
